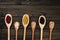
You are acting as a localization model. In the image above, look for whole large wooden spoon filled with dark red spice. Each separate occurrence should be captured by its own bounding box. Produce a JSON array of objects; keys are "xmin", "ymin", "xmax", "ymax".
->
[{"xmin": 5, "ymin": 14, "xmax": 12, "ymax": 40}]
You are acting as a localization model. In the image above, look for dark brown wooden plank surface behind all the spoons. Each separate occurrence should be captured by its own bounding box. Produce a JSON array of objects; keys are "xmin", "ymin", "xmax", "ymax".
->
[{"xmin": 0, "ymin": 0, "xmax": 60, "ymax": 40}]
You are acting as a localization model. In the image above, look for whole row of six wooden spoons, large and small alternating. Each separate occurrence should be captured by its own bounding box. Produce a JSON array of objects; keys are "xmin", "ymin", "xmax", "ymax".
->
[{"xmin": 5, "ymin": 14, "xmax": 55, "ymax": 40}]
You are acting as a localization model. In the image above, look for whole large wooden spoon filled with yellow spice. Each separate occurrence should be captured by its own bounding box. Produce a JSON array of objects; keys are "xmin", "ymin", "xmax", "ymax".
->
[{"xmin": 22, "ymin": 14, "xmax": 29, "ymax": 40}]
